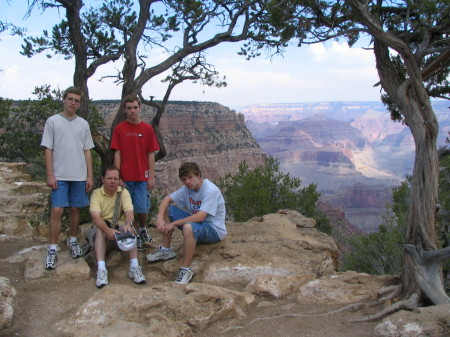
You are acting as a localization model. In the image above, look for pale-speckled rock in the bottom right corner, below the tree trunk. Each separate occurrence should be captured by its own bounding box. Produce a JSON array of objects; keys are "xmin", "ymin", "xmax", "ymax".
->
[{"xmin": 374, "ymin": 304, "xmax": 450, "ymax": 337}]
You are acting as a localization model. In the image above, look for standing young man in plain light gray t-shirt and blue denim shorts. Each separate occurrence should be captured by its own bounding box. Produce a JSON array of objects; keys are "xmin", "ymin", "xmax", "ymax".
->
[{"xmin": 41, "ymin": 87, "xmax": 94, "ymax": 269}]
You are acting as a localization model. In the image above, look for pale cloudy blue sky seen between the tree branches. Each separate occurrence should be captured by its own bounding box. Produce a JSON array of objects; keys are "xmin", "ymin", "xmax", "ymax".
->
[{"xmin": 0, "ymin": 0, "xmax": 380, "ymax": 108}]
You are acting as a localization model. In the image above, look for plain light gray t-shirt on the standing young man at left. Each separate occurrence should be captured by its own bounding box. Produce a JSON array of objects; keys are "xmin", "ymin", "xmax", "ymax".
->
[{"xmin": 41, "ymin": 114, "xmax": 94, "ymax": 181}]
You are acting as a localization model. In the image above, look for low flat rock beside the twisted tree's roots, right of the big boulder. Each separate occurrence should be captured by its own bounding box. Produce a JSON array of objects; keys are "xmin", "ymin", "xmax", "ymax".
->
[{"xmin": 297, "ymin": 271, "xmax": 398, "ymax": 304}]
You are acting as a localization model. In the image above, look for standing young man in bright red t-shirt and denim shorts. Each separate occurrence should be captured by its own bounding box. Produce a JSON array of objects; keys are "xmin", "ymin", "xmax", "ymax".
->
[{"xmin": 111, "ymin": 95, "xmax": 159, "ymax": 249}]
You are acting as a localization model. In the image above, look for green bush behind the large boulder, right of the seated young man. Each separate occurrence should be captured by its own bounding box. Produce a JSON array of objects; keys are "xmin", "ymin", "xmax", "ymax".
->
[{"xmin": 218, "ymin": 157, "xmax": 331, "ymax": 233}]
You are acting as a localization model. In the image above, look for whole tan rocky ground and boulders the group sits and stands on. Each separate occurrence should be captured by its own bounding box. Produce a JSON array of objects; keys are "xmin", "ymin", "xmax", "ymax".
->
[{"xmin": 0, "ymin": 164, "xmax": 450, "ymax": 337}]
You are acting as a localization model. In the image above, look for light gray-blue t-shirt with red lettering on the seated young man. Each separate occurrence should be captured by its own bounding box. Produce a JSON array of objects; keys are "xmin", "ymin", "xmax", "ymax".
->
[{"xmin": 170, "ymin": 179, "xmax": 227, "ymax": 240}]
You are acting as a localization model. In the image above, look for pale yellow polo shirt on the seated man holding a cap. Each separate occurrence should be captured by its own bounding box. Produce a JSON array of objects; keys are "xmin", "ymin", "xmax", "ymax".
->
[{"xmin": 89, "ymin": 186, "xmax": 133, "ymax": 224}]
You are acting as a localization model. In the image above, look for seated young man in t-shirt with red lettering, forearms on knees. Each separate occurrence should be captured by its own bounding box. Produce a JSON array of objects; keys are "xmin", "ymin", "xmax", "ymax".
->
[{"xmin": 145, "ymin": 162, "xmax": 227, "ymax": 284}]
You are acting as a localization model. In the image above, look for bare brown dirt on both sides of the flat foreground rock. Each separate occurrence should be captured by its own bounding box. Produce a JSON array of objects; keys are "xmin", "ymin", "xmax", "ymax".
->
[{"xmin": 0, "ymin": 239, "xmax": 377, "ymax": 337}]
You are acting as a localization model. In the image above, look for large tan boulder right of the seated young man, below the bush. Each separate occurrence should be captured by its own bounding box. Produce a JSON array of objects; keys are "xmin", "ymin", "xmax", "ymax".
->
[{"xmin": 199, "ymin": 211, "xmax": 339, "ymax": 287}]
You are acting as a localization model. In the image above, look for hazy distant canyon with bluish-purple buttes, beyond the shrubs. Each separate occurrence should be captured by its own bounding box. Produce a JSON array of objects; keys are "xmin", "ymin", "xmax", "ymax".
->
[{"xmin": 243, "ymin": 102, "xmax": 450, "ymax": 232}]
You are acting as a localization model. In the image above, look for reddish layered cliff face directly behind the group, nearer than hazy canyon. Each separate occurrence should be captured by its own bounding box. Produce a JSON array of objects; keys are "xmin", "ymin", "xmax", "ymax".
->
[{"xmin": 95, "ymin": 101, "xmax": 265, "ymax": 192}]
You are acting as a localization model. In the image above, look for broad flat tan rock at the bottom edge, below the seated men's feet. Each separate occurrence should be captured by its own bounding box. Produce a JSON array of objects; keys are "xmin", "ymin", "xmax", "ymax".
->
[{"xmin": 56, "ymin": 282, "xmax": 255, "ymax": 337}]
